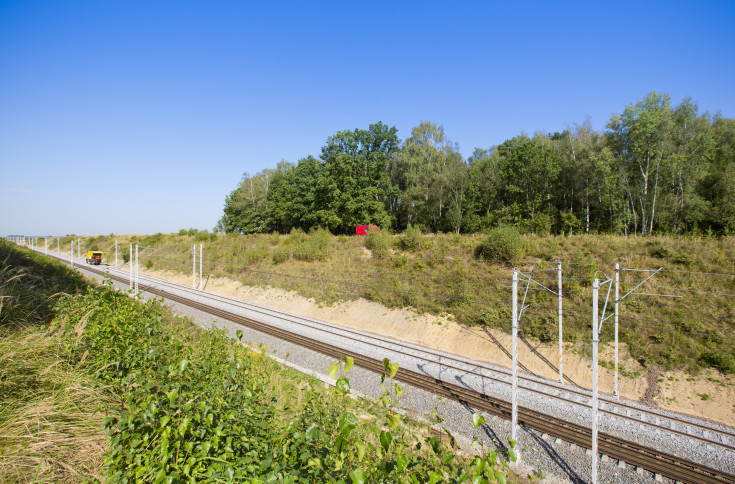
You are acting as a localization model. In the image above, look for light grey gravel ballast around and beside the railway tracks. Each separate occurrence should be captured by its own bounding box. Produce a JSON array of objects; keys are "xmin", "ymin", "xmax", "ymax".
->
[{"xmin": 53, "ymin": 253, "xmax": 735, "ymax": 483}]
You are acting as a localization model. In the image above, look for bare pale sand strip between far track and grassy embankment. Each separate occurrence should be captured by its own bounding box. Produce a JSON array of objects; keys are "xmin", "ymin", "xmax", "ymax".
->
[{"xmin": 146, "ymin": 271, "xmax": 735, "ymax": 426}]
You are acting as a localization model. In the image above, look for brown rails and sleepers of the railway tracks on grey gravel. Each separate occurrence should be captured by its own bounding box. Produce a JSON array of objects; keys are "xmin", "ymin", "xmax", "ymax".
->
[{"xmin": 46, "ymin": 251, "xmax": 735, "ymax": 484}]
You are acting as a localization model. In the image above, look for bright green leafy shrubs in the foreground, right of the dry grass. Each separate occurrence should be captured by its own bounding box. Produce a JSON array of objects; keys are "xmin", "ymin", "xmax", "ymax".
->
[{"xmin": 44, "ymin": 274, "xmax": 507, "ymax": 482}]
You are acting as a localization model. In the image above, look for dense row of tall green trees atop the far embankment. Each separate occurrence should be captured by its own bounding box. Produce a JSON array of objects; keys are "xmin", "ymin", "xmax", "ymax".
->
[{"xmin": 215, "ymin": 92, "xmax": 735, "ymax": 235}]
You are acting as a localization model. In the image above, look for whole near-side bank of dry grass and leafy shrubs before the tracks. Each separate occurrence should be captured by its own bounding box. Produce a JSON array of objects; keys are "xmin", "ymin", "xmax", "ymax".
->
[{"xmin": 0, "ymin": 241, "xmax": 539, "ymax": 484}]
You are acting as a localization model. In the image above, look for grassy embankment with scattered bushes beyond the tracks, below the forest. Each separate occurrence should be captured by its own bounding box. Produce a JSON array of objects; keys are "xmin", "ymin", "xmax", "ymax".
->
[{"xmin": 47, "ymin": 230, "xmax": 735, "ymax": 373}]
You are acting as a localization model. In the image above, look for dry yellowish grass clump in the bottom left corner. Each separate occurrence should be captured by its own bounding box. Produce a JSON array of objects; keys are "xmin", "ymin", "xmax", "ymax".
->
[{"xmin": 0, "ymin": 326, "xmax": 112, "ymax": 482}]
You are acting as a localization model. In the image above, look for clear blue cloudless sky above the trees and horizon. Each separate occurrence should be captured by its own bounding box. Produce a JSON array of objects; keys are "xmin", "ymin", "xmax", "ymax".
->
[{"xmin": 0, "ymin": 0, "xmax": 735, "ymax": 235}]
